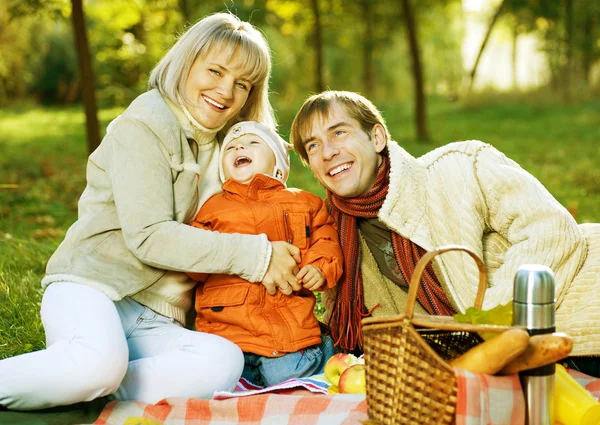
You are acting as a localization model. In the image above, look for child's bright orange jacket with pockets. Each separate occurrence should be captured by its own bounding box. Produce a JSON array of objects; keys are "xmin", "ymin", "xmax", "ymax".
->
[{"xmin": 189, "ymin": 174, "xmax": 342, "ymax": 357}]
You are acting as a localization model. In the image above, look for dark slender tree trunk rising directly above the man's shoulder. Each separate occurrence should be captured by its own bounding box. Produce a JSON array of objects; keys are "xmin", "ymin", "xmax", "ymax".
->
[{"xmin": 400, "ymin": 0, "xmax": 430, "ymax": 142}]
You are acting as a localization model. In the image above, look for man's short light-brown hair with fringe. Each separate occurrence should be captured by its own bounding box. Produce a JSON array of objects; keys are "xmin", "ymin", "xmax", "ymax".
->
[{"xmin": 290, "ymin": 90, "xmax": 391, "ymax": 164}]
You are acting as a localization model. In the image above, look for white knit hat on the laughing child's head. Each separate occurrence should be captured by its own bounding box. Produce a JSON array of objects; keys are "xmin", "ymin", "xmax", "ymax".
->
[{"xmin": 219, "ymin": 121, "xmax": 292, "ymax": 184}]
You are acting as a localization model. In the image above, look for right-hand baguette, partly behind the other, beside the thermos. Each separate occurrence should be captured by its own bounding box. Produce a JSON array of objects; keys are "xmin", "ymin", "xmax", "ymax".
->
[{"xmin": 500, "ymin": 332, "xmax": 573, "ymax": 375}]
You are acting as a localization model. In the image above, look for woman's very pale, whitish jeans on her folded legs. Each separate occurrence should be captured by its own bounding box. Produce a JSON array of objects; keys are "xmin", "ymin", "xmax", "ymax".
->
[{"xmin": 0, "ymin": 282, "xmax": 244, "ymax": 410}]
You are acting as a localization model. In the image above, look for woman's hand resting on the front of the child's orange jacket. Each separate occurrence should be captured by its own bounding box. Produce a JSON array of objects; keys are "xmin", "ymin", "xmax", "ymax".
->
[{"xmin": 262, "ymin": 241, "xmax": 302, "ymax": 295}]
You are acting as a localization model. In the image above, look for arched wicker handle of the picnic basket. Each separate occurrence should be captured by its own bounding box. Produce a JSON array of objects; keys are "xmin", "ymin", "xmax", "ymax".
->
[{"xmin": 404, "ymin": 245, "xmax": 487, "ymax": 320}]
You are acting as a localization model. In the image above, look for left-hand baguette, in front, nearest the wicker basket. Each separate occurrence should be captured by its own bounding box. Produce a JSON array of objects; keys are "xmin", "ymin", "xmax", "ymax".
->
[{"xmin": 450, "ymin": 328, "xmax": 529, "ymax": 375}]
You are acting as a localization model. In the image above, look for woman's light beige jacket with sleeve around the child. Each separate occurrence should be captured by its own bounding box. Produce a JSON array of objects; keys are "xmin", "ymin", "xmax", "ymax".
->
[{"xmin": 42, "ymin": 90, "xmax": 271, "ymax": 322}]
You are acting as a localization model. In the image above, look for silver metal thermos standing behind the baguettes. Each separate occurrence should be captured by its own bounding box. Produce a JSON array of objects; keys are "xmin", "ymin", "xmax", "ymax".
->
[{"xmin": 513, "ymin": 264, "xmax": 555, "ymax": 425}]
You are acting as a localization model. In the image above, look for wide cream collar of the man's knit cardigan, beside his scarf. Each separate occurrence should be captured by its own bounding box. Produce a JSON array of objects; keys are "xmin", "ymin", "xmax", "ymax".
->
[{"xmin": 378, "ymin": 140, "xmax": 434, "ymax": 251}]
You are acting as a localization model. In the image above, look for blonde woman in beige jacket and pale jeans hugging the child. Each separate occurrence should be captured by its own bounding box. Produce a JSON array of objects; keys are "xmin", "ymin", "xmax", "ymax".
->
[{"xmin": 0, "ymin": 13, "xmax": 299, "ymax": 410}]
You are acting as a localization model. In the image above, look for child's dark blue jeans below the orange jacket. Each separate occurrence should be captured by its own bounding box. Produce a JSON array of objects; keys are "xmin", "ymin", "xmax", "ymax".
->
[{"xmin": 242, "ymin": 335, "xmax": 334, "ymax": 387}]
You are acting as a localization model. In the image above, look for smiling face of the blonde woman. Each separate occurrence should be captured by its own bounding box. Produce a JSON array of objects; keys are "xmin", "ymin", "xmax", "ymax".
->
[{"xmin": 185, "ymin": 51, "xmax": 252, "ymax": 128}]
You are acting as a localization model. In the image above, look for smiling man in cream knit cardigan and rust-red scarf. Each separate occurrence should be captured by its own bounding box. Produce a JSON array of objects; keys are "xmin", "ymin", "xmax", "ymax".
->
[{"xmin": 291, "ymin": 91, "xmax": 600, "ymax": 376}]
